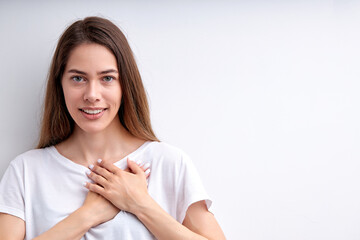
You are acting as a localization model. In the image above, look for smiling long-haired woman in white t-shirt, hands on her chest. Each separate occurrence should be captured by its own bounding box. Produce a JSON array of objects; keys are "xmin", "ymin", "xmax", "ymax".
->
[{"xmin": 0, "ymin": 17, "xmax": 225, "ymax": 240}]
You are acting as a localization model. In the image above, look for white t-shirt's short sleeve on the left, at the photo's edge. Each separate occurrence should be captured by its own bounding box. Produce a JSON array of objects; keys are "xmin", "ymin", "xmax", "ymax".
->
[{"xmin": 0, "ymin": 161, "xmax": 25, "ymax": 221}]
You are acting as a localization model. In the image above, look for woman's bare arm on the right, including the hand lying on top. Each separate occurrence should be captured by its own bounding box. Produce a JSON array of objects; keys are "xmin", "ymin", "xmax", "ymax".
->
[{"xmin": 86, "ymin": 160, "xmax": 225, "ymax": 240}]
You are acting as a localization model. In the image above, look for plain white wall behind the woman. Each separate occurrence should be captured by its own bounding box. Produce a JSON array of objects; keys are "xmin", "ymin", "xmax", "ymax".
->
[{"xmin": 0, "ymin": 0, "xmax": 360, "ymax": 240}]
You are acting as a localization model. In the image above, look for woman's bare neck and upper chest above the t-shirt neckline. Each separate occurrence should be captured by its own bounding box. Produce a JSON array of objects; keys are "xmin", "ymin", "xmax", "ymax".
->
[{"xmin": 55, "ymin": 119, "xmax": 145, "ymax": 166}]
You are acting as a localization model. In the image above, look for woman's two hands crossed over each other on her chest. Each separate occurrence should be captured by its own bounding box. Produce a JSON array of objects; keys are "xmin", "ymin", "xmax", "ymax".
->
[{"xmin": 83, "ymin": 159, "xmax": 151, "ymax": 226}]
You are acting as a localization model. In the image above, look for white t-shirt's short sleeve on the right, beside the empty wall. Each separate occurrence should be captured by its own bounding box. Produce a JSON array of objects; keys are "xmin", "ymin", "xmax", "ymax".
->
[{"xmin": 176, "ymin": 153, "xmax": 212, "ymax": 223}]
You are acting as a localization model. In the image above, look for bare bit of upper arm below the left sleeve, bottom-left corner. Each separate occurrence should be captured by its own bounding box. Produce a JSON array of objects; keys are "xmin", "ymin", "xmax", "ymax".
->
[{"xmin": 0, "ymin": 213, "xmax": 25, "ymax": 240}]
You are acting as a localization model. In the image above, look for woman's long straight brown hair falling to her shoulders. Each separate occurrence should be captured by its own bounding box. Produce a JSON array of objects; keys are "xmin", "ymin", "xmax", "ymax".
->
[{"xmin": 37, "ymin": 17, "xmax": 159, "ymax": 148}]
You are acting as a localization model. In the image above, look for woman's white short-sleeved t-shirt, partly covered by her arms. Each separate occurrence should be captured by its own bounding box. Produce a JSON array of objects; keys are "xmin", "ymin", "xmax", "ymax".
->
[{"xmin": 0, "ymin": 141, "xmax": 211, "ymax": 240}]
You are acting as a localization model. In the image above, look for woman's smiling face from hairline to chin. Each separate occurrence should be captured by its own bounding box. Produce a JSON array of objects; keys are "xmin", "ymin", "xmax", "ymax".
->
[{"xmin": 61, "ymin": 43, "xmax": 121, "ymax": 133}]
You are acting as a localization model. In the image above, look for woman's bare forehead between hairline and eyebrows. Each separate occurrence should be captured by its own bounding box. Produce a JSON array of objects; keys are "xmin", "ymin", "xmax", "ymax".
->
[{"xmin": 66, "ymin": 43, "xmax": 118, "ymax": 71}]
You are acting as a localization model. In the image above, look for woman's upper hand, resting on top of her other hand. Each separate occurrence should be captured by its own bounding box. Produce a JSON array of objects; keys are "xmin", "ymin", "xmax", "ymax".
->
[{"xmin": 86, "ymin": 159, "xmax": 150, "ymax": 213}]
